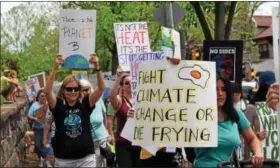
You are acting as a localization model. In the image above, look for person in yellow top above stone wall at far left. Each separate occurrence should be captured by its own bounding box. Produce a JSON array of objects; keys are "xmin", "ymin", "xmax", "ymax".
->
[{"xmin": 0, "ymin": 69, "xmax": 18, "ymax": 100}]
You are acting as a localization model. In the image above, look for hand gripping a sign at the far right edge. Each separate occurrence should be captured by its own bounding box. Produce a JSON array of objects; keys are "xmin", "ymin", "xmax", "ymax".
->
[{"xmin": 266, "ymin": 83, "xmax": 279, "ymax": 110}]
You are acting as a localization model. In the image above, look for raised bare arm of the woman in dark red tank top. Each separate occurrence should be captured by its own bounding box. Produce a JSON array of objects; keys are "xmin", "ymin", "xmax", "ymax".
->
[{"xmin": 108, "ymin": 66, "xmax": 122, "ymax": 112}]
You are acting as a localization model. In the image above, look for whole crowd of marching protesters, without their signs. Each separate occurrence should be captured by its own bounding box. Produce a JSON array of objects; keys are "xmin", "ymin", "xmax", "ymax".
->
[{"xmin": 20, "ymin": 54, "xmax": 279, "ymax": 167}]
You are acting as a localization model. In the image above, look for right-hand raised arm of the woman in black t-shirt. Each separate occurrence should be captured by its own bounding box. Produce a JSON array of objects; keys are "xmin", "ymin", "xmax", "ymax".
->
[{"xmin": 89, "ymin": 54, "xmax": 105, "ymax": 107}]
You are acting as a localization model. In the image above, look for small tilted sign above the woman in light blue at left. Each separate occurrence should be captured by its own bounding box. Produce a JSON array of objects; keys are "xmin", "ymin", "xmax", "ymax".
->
[{"xmin": 25, "ymin": 77, "xmax": 40, "ymax": 101}]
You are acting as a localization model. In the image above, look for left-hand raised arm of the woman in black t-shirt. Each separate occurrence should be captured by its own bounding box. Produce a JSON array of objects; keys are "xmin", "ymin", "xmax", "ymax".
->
[{"xmin": 45, "ymin": 54, "xmax": 64, "ymax": 109}]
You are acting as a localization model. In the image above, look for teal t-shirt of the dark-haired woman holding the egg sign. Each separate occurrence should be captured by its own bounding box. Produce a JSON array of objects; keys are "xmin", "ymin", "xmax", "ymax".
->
[{"xmin": 194, "ymin": 109, "xmax": 250, "ymax": 167}]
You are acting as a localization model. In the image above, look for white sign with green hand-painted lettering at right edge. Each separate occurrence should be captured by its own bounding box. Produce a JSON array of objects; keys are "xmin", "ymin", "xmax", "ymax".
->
[{"xmin": 255, "ymin": 102, "xmax": 279, "ymax": 160}]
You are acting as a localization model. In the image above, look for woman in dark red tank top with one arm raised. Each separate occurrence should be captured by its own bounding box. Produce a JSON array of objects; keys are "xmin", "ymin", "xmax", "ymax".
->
[{"xmin": 109, "ymin": 66, "xmax": 140, "ymax": 167}]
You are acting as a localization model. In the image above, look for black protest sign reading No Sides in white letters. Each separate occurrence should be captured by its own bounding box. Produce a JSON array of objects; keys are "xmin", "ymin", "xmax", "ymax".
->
[{"xmin": 203, "ymin": 40, "xmax": 243, "ymax": 85}]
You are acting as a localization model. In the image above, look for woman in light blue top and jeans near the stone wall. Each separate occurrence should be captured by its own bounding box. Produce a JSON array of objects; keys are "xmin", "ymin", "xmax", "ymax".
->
[{"xmin": 27, "ymin": 90, "xmax": 52, "ymax": 167}]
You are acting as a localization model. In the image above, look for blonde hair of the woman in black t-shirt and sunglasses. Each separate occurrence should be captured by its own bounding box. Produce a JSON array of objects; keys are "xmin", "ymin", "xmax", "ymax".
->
[{"xmin": 57, "ymin": 75, "xmax": 83, "ymax": 100}]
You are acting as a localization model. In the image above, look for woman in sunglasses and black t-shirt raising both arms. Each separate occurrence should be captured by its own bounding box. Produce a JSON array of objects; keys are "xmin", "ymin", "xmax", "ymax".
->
[{"xmin": 45, "ymin": 54, "xmax": 105, "ymax": 167}]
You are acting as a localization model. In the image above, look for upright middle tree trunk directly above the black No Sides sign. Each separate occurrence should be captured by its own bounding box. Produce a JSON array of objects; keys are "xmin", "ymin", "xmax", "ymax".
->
[{"xmin": 215, "ymin": 1, "xmax": 225, "ymax": 40}]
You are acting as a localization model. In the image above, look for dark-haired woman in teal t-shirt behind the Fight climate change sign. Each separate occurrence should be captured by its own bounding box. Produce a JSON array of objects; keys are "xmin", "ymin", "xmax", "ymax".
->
[{"xmin": 167, "ymin": 60, "xmax": 263, "ymax": 167}]
